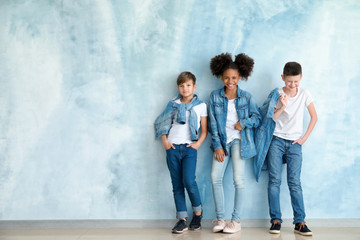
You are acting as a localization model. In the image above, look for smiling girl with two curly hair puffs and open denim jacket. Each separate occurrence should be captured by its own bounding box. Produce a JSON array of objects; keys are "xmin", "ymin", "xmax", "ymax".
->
[{"xmin": 208, "ymin": 53, "xmax": 261, "ymax": 233}]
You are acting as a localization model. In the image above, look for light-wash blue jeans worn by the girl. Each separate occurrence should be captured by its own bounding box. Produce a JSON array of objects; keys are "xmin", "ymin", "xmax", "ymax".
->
[{"xmin": 211, "ymin": 139, "xmax": 245, "ymax": 222}]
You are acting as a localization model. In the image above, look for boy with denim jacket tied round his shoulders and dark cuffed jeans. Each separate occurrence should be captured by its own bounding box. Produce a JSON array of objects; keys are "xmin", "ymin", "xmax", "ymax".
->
[{"xmin": 155, "ymin": 72, "xmax": 207, "ymax": 233}]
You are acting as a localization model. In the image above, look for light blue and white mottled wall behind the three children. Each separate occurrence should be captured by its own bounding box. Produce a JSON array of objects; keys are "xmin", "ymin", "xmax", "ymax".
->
[{"xmin": 0, "ymin": 0, "xmax": 360, "ymax": 220}]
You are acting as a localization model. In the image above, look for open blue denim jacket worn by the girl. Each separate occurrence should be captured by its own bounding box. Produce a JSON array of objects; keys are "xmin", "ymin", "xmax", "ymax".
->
[{"xmin": 208, "ymin": 87, "xmax": 261, "ymax": 159}]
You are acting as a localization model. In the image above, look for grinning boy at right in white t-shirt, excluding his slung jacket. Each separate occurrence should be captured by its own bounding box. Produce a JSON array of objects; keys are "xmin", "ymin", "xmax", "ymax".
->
[{"xmin": 267, "ymin": 62, "xmax": 317, "ymax": 236}]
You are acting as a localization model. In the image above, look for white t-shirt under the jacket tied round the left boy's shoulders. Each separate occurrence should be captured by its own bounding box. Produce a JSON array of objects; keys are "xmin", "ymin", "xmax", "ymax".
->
[{"xmin": 168, "ymin": 99, "xmax": 207, "ymax": 144}]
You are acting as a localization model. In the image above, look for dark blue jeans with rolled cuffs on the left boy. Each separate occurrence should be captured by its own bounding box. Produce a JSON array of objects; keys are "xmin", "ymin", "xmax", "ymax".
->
[{"xmin": 166, "ymin": 144, "xmax": 201, "ymax": 218}]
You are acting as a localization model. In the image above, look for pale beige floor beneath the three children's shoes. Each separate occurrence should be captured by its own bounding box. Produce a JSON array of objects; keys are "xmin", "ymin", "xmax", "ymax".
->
[{"xmin": 0, "ymin": 227, "xmax": 360, "ymax": 240}]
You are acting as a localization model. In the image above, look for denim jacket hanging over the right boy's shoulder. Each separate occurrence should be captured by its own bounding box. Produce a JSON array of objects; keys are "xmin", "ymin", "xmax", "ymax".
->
[{"xmin": 254, "ymin": 88, "xmax": 279, "ymax": 181}]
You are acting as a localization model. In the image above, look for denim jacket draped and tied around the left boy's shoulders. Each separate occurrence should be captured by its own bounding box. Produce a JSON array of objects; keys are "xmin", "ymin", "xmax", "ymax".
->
[{"xmin": 155, "ymin": 94, "xmax": 203, "ymax": 141}]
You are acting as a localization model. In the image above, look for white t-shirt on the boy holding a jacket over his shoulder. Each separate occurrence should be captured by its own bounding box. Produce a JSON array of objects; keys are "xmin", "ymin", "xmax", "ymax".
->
[{"xmin": 274, "ymin": 87, "xmax": 313, "ymax": 140}]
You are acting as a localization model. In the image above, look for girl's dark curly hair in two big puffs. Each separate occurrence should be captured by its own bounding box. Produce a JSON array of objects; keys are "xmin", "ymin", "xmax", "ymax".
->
[{"xmin": 210, "ymin": 53, "xmax": 254, "ymax": 80}]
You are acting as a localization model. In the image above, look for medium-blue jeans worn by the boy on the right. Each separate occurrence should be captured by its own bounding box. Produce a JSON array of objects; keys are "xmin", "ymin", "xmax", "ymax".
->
[{"xmin": 267, "ymin": 136, "xmax": 305, "ymax": 223}]
